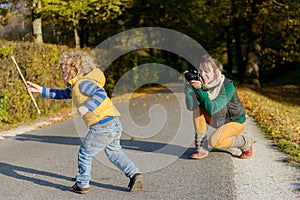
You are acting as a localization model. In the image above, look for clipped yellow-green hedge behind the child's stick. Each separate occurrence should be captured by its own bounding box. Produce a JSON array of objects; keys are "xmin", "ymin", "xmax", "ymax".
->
[{"xmin": 0, "ymin": 40, "xmax": 71, "ymax": 128}]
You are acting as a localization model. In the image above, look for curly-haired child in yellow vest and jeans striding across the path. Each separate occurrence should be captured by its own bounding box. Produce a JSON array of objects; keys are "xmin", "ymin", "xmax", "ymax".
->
[{"xmin": 27, "ymin": 51, "xmax": 143, "ymax": 194}]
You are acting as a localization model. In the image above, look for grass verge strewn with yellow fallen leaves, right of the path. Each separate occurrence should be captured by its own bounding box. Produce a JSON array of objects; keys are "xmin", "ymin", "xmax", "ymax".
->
[{"xmin": 238, "ymin": 87, "xmax": 300, "ymax": 168}]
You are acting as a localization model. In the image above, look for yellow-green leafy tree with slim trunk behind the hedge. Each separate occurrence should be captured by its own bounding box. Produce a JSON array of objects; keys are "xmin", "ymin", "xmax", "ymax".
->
[{"xmin": 42, "ymin": 0, "xmax": 131, "ymax": 48}]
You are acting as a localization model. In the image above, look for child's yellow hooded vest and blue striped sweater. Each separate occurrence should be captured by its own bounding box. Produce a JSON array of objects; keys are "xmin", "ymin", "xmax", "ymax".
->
[{"xmin": 42, "ymin": 68, "xmax": 120, "ymax": 126}]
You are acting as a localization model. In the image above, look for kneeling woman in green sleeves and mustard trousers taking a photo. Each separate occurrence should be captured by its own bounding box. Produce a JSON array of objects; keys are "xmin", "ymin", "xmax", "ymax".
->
[{"xmin": 184, "ymin": 56, "xmax": 253, "ymax": 159}]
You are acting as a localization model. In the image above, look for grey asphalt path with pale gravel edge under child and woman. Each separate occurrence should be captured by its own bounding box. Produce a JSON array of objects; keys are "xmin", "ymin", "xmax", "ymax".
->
[{"xmin": 0, "ymin": 85, "xmax": 300, "ymax": 200}]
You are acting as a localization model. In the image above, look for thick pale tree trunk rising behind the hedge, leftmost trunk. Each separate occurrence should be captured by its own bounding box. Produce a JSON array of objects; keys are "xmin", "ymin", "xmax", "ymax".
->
[{"xmin": 32, "ymin": 0, "xmax": 43, "ymax": 43}]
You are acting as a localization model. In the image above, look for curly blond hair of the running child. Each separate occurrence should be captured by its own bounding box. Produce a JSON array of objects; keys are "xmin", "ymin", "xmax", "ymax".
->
[{"xmin": 58, "ymin": 51, "xmax": 97, "ymax": 76}]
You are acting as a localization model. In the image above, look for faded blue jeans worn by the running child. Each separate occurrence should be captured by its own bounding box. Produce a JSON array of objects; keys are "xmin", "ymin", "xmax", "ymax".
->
[{"xmin": 76, "ymin": 117, "xmax": 139, "ymax": 188}]
